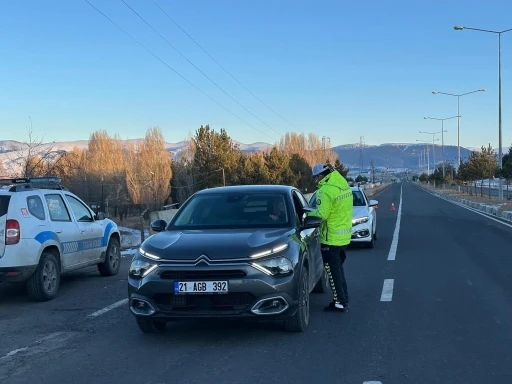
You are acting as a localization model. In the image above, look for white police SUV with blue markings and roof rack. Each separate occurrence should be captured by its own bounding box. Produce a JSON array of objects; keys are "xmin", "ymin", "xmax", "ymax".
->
[{"xmin": 0, "ymin": 177, "xmax": 121, "ymax": 301}]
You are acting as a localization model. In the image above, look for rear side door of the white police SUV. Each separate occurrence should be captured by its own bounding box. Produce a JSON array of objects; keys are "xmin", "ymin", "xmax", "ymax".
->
[{"xmin": 44, "ymin": 192, "xmax": 83, "ymax": 269}]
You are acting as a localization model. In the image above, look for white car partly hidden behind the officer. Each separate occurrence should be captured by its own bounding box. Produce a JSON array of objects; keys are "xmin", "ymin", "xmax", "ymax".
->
[{"xmin": 309, "ymin": 187, "xmax": 379, "ymax": 248}]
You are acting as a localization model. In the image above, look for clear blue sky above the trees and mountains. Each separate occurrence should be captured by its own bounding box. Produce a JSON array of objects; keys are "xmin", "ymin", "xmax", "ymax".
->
[{"xmin": 0, "ymin": 0, "xmax": 512, "ymax": 147}]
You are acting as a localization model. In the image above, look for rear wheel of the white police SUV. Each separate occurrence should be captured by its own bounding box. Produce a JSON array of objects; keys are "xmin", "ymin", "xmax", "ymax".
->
[{"xmin": 26, "ymin": 252, "xmax": 60, "ymax": 301}]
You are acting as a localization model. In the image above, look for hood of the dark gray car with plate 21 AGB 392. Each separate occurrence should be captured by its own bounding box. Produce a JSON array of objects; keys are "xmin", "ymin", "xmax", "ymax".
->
[{"xmin": 141, "ymin": 228, "xmax": 293, "ymax": 260}]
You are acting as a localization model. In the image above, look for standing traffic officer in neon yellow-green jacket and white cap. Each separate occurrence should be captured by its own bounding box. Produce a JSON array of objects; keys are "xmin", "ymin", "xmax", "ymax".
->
[{"xmin": 310, "ymin": 164, "xmax": 354, "ymax": 312}]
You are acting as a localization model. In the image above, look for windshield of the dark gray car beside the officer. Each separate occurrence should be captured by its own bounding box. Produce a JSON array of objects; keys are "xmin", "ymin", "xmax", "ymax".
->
[{"xmin": 168, "ymin": 192, "xmax": 291, "ymax": 229}]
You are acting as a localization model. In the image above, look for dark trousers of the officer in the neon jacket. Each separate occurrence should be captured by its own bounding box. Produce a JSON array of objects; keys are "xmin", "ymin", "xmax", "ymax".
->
[{"xmin": 321, "ymin": 244, "xmax": 348, "ymax": 306}]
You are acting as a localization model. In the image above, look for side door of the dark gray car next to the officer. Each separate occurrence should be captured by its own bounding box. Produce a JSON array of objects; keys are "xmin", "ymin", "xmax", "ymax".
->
[{"xmin": 293, "ymin": 190, "xmax": 324, "ymax": 287}]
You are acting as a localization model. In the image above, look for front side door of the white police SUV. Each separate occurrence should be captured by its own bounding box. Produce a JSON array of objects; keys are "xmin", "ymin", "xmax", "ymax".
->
[{"xmin": 64, "ymin": 193, "xmax": 103, "ymax": 262}]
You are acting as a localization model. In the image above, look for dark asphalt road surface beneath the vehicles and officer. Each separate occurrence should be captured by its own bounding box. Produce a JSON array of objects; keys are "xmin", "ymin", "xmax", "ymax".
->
[{"xmin": 0, "ymin": 183, "xmax": 512, "ymax": 384}]
